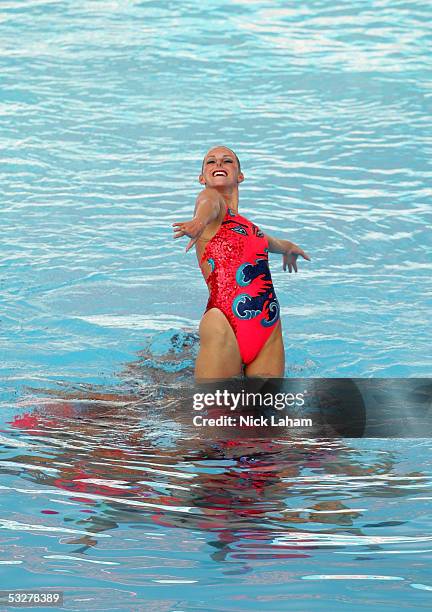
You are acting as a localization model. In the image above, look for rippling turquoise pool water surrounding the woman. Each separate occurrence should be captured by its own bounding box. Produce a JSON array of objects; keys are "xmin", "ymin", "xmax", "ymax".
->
[{"xmin": 0, "ymin": 0, "xmax": 432, "ymax": 610}]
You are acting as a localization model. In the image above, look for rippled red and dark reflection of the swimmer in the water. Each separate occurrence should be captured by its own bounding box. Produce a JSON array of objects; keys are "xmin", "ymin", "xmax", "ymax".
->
[{"xmin": 6, "ymin": 364, "xmax": 422, "ymax": 571}]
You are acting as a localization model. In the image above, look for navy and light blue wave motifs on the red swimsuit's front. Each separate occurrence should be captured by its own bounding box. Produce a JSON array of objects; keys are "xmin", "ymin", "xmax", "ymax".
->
[{"xmin": 232, "ymin": 259, "xmax": 280, "ymax": 327}]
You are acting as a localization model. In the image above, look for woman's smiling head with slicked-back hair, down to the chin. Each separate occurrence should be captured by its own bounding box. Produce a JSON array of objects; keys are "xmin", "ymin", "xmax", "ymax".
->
[{"xmin": 199, "ymin": 147, "xmax": 244, "ymax": 188}]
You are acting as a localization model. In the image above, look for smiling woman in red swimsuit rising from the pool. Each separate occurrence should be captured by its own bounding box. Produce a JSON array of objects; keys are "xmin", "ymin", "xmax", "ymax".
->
[{"xmin": 173, "ymin": 146, "xmax": 310, "ymax": 380}]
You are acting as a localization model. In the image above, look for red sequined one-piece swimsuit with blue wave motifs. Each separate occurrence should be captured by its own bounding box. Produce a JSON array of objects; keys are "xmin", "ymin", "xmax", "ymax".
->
[{"xmin": 201, "ymin": 208, "xmax": 279, "ymax": 365}]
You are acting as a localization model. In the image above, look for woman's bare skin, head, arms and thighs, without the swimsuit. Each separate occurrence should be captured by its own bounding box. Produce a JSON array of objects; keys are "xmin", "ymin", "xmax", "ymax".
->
[{"xmin": 173, "ymin": 147, "xmax": 309, "ymax": 380}]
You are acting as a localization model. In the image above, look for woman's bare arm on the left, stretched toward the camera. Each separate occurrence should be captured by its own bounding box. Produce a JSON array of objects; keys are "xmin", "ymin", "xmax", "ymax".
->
[{"xmin": 173, "ymin": 188, "xmax": 221, "ymax": 252}]
